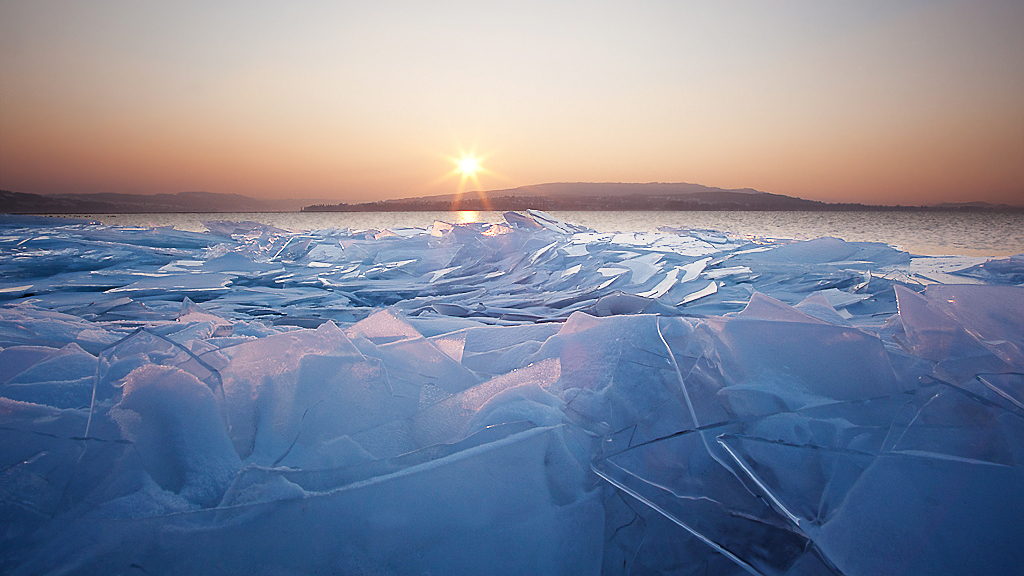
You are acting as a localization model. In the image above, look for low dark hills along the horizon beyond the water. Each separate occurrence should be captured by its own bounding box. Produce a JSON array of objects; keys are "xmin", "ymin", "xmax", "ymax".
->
[{"xmin": 0, "ymin": 182, "xmax": 1024, "ymax": 215}]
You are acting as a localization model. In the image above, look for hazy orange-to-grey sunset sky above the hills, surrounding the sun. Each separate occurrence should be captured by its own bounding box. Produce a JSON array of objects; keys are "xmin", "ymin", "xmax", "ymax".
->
[{"xmin": 0, "ymin": 0, "xmax": 1024, "ymax": 203}]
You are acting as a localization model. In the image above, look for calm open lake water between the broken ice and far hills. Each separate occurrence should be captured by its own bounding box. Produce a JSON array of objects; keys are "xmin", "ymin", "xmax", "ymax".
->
[{"xmin": 56, "ymin": 211, "xmax": 1024, "ymax": 256}]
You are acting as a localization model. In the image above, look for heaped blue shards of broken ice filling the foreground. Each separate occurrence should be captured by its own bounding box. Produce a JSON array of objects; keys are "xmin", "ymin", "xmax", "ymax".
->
[{"xmin": 0, "ymin": 211, "xmax": 1024, "ymax": 576}]
